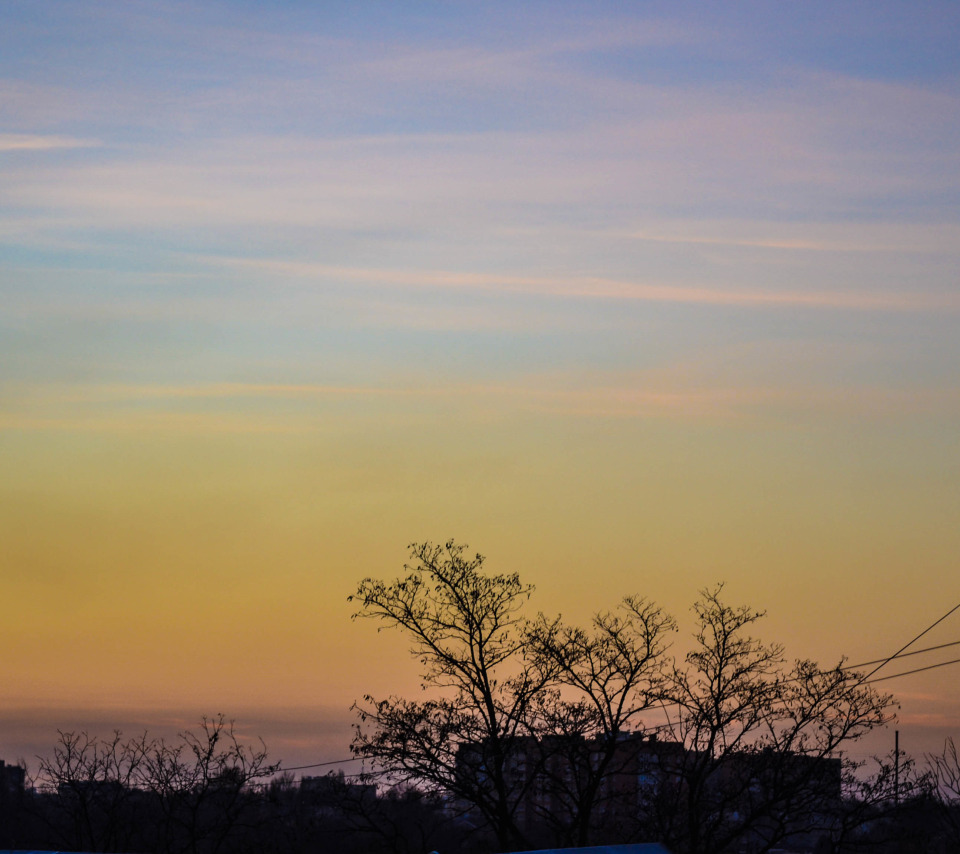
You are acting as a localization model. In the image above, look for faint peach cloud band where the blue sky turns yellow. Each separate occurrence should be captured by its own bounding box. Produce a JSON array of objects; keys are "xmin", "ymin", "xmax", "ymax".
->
[{"xmin": 7, "ymin": 382, "xmax": 960, "ymax": 435}]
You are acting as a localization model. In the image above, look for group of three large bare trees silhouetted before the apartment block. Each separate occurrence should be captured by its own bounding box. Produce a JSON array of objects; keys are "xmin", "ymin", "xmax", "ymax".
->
[{"xmin": 350, "ymin": 541, "xmax": 892, "ymax": 854}]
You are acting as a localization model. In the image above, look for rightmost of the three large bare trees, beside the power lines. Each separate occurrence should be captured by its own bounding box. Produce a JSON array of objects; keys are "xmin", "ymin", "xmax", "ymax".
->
[{"xmin": 655, "ymin": 586, "xmax": 893, "ymax": 854}]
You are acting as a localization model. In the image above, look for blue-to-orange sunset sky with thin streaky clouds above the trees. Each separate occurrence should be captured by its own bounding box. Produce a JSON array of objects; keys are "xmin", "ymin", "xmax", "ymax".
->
[{"xmin": 0, "ymin": 0, "xmax": 960, "ymax": 767}]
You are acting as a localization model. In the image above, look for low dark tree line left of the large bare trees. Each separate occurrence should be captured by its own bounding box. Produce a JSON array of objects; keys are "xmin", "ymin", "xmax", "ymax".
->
[{"xmin": 0, "ymin": 716, "xmax": 464, "ymax": 854}]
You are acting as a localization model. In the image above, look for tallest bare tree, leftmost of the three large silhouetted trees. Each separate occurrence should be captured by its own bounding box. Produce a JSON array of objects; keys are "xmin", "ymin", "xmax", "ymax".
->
[{"xmin": 350, "ymin": 541, "xmax": 544, "ymax": 847}]
